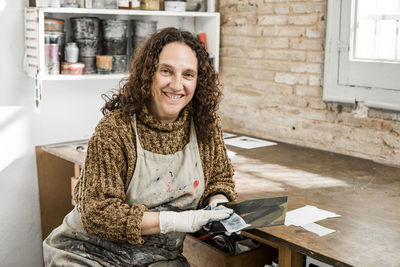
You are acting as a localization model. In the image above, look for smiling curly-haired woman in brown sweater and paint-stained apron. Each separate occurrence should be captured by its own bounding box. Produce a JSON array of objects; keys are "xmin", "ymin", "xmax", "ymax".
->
[{"xmin": 43, "ymin": 28, "xmax": 236, "ymax": 266}]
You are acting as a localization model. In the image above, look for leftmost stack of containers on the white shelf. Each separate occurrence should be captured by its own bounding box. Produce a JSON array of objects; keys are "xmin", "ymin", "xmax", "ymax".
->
[{"xmin": 44, "ymin": 18, "xmax": 65, "ymax": 75}]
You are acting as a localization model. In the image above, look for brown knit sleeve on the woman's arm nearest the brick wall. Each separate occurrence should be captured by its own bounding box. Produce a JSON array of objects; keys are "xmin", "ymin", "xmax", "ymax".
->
[{"xmin": 199, "ymin": 116, "xmax": 237, "ymax": 207}]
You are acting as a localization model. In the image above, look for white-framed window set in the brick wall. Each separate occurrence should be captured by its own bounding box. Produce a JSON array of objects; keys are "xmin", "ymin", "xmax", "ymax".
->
[{"xmin": 323, "ymin": 0, "xmax": 400, "ymax": 111}]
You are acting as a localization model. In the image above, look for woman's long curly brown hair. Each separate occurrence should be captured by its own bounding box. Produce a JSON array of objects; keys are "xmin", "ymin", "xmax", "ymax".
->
[{"xmin": 101, "ymin": 27, "xmax": 222, "ymax": 141}]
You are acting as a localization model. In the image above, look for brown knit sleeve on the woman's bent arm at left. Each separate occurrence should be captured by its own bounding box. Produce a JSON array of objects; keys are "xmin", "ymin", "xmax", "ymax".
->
[{"xmin": 78, "ymin": 113, "xmax": 147, "ymax": 244}]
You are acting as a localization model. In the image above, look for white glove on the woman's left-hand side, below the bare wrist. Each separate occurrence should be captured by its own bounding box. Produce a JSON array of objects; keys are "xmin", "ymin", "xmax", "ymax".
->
[{"xmin": 160, "ymin": 209, "xmax": 233, "ymax": 234}]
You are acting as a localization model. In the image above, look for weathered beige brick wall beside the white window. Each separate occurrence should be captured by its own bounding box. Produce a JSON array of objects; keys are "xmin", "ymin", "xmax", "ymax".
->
[{"xmin": 219, "ymin": 0, "xmax": 400, "ymax": 166}]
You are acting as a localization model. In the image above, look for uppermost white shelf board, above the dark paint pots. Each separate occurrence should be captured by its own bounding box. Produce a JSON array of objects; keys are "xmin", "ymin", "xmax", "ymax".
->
[{"xmin": 39, "ymin": 7, "xmax": 219, "ymax": 17}]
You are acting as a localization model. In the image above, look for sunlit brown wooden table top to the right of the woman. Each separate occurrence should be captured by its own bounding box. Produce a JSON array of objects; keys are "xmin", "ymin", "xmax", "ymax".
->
[{"xmin": 228, "ymin": 141, "xmax": 400, "ymax": 266}]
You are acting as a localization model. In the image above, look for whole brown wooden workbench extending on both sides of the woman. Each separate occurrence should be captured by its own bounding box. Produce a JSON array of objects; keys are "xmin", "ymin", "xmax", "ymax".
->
[{"xmin": 36, "ymin": 140, "xmax": 400, "ymax": 267}]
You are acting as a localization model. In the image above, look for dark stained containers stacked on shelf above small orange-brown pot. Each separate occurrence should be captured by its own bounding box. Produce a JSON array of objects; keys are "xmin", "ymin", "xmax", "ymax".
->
[{"xmin": 96, "ymin": 19, "xmax": 128, "ymax": 74}]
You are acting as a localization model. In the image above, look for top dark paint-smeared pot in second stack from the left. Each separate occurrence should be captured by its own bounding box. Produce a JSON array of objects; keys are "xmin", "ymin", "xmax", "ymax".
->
[{"xmin": 70, "ymin": 17, "xmax": 100, "ymax": 40}]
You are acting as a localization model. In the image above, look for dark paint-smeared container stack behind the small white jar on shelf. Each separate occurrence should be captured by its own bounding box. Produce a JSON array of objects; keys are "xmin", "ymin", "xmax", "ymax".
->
[{"xmin": 71, "ymin": 17, "xmax": 101, "ymax": 74}]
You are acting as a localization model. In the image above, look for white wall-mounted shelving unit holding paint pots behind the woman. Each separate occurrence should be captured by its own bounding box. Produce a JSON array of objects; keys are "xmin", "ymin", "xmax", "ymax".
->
[{"xmin": 25, "ymin": 7, "xmax": 220, "ymax": 82}]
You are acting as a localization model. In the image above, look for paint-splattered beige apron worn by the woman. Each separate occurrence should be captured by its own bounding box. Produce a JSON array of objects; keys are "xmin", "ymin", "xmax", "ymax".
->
[{"xmin": 43, "ymin": 116, "xmax": 205, "ymax": 267}]
